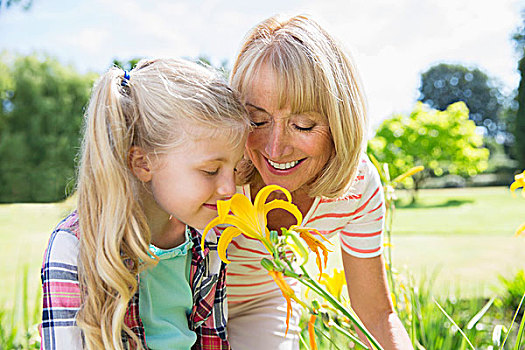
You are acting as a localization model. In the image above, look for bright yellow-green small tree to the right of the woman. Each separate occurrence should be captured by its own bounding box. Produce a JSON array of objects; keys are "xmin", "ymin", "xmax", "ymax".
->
[{"xmin": 368, "ymin": 102, "xmax": 489, "ymax": 199}]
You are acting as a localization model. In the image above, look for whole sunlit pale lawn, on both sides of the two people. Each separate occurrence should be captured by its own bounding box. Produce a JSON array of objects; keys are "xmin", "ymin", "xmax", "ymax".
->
[{"xmin": 0, "ymin": 187, "xmax": 525, "ymax": 305}]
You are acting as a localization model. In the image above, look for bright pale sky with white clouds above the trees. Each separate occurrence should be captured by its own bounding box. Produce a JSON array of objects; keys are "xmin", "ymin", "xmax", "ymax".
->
[{"xmin": 0, "ymin": 0, "xmax": 525, "ymax": 125}]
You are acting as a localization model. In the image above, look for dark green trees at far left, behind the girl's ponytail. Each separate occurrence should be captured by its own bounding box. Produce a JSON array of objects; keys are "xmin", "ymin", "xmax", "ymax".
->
[{"xmin": 0, "ymin": 55, "xmax": 95, "ymax": 202}]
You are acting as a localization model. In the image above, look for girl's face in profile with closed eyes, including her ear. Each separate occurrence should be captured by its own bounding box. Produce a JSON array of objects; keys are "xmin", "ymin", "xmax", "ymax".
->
[{"xmin": 150, "ymin": 133, "xmax": 244, "ymax": 229}]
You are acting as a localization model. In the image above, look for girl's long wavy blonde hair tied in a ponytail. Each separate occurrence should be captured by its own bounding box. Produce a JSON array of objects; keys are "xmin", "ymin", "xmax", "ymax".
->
[{"xmin": 76, "ymin": 59, "xmax": 249, "ymax": 349}]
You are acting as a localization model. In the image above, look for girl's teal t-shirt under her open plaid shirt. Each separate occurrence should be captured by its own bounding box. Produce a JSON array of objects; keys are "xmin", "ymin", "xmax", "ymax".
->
[{"xmin": 139, "ymin": 228, "xmax": 197, "ymax": 350}]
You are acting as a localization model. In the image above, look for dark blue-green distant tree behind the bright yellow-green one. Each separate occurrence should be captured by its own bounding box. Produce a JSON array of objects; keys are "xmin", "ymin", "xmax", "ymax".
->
[{"xmin": 419, "ymin": 63, "xmax": 506, "ymax": 143}]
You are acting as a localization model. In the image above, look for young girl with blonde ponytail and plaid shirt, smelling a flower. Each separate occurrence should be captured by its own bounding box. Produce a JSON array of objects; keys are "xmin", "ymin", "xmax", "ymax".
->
[{"xmin": 41, "ymin": 59, "xmax": 250, "ymax": 349}]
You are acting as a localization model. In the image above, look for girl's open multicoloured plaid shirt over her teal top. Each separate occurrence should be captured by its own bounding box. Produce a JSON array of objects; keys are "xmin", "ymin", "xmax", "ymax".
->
[{"xmin": 40, "ymin": 211, "xmax": 231, "ymax": 350}]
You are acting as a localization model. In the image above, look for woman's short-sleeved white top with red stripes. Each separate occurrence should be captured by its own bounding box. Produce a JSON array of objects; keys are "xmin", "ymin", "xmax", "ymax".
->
[{"xmin": 226, "ymin": 155, "xmax": 385, "ymax": 304}]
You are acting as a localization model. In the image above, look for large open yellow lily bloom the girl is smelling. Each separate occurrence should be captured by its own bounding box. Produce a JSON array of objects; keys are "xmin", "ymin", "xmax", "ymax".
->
[{"xmin": 201, "ymin": 185, "xmax": 303, "ymax": 263}]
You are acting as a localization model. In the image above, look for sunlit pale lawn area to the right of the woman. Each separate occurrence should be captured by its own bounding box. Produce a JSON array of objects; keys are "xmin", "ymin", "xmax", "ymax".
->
[{"xmin": 393, "ymin": 187, "xmax": 525, "ymax": 296}]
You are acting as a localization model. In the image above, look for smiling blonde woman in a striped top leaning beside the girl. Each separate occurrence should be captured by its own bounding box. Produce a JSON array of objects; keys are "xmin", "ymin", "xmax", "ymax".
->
[{"xmin": 227, "ymin": 16, "xmax": 412, "ymax": 350}]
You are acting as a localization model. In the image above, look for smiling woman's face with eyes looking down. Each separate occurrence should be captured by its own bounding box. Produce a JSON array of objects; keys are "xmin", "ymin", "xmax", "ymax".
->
[{"xmin": 246, "ymin": 67, "xmax": 334, "ymax": 196}]
